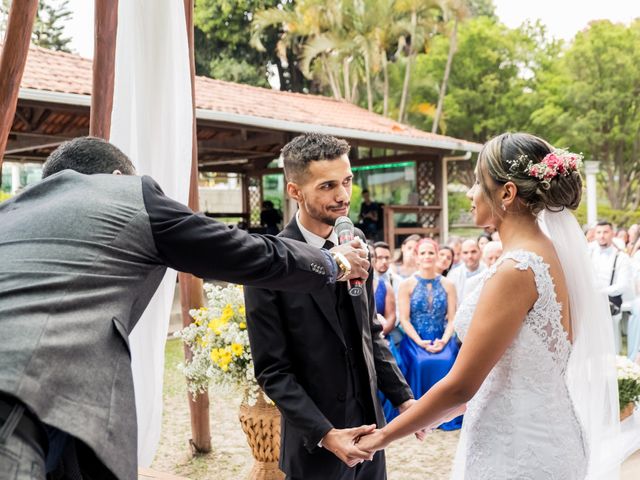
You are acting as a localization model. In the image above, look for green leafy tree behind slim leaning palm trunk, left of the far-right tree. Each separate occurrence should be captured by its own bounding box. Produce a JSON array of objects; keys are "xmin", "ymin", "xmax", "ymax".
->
[{"xmin": 409, "ymin": 17, "xmax": 548, "ymax": 142}]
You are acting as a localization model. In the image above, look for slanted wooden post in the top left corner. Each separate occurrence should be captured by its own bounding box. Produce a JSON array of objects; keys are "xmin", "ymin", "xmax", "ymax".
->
[{"xmin": 0, "ymin": 0, "xmax": 38, "ymax": 176}]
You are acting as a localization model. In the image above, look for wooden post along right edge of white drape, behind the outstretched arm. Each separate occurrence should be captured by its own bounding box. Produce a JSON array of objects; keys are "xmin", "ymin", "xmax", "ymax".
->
[{"xmin": 178, "ymin": 0, "xmax": 211, "ymax": 453}]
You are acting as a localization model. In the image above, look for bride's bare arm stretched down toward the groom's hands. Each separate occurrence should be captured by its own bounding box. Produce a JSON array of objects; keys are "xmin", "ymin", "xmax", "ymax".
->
[{"xmin": 359, "ymin": 261, "xmax": 538, "ymax": 450}]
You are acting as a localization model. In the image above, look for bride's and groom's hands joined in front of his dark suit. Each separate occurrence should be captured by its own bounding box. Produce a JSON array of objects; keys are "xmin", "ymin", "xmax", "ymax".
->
[{"xmin": 322, "ymin": 399, "xmax": 427, "ymax": 467}]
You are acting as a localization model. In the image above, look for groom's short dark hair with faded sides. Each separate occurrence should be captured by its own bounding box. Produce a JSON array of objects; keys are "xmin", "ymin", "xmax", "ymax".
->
[{"xmin": 281, "ymin": 133, "xmax": 351, "ymax": 183}]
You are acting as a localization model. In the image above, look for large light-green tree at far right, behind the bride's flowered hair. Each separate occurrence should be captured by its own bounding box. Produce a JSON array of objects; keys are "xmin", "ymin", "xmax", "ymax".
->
[{"xmin": 532, "ymin": 20, "xmax": 640, "ymax": 209}]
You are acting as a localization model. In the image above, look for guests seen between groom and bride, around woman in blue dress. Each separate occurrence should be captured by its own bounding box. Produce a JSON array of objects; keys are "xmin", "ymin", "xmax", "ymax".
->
[{"xmin": 371, "ymin": 232, "xmax": 502, "ymax": 430}]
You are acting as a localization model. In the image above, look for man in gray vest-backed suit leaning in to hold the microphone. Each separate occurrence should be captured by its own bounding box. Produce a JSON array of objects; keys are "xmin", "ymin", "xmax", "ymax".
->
[{"xmin": 0, "ymin": 137, "xmax": 369, "ymax": 480}]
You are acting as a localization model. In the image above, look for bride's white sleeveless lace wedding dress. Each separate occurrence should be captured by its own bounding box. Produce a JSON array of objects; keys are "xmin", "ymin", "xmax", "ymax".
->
[{"xmin": 452, "ymin": 250, "xmax": 587, "ymax": 480}]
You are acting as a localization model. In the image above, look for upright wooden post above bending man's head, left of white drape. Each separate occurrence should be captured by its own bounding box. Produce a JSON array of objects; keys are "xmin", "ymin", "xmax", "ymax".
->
[{"xmin": 89, "ymin": 0, "xmax": 118, "ymax": 140}]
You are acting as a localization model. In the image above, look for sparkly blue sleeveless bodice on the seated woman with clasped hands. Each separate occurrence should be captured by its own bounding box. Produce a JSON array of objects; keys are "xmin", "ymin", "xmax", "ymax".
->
[{"xmin": 409, "ymin": 275, "xmax": 447, "ymax": 340}]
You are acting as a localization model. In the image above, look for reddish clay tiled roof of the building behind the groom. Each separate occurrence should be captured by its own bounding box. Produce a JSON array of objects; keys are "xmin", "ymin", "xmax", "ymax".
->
[{"xmin": 16, "ymin": 46, "xmax": 479, "ymax": 151}]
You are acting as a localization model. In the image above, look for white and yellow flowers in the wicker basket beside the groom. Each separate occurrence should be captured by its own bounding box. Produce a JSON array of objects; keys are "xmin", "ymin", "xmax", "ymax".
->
[{"xmin": 174, "ymin": 284, "xmax": 261, "ymax": 405}]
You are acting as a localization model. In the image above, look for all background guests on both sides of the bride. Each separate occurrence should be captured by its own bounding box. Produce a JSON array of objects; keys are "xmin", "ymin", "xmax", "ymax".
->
[{"xmin": 371, "ymin": 221, "xmax": 640, "ymax": 430}]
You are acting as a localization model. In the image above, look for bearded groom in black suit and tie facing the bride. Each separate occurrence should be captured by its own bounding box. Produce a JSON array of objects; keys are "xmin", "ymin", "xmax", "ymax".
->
[{"xmin": 245, "ymin": 134, "xmax": 414, "ymax": 480}]
